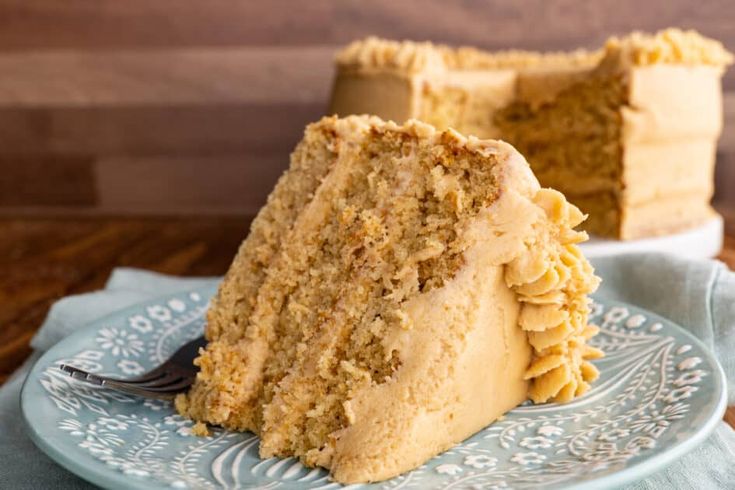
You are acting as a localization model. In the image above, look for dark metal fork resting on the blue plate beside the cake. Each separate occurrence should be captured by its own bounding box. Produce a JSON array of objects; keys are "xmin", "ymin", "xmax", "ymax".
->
[{"xmin": 59, "ymin": 337, "xmax": 207, "ymax": 400}]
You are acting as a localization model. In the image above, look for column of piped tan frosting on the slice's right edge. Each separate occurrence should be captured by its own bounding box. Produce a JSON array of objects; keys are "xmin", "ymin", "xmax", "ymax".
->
[{"xmin": 505, "ymin": 189, "xmax": 603, "ymax": 403}]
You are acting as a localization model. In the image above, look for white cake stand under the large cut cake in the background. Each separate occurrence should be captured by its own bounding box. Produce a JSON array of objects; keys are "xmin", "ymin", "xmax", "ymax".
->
[{"xmin": 581, "ymin": 215, "xmax": 724, "ymax": 259}]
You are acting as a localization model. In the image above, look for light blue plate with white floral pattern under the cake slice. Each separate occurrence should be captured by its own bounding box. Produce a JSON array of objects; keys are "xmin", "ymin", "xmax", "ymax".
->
[{"xmin": 21, "ymin": 288, "xmax": 725, "ymax": 489}]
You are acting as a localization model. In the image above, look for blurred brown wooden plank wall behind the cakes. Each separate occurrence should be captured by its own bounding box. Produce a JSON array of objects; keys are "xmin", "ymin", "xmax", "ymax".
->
[{"xmin": 0, "ymin": 0, "xmax": 735, "ymax": 216}]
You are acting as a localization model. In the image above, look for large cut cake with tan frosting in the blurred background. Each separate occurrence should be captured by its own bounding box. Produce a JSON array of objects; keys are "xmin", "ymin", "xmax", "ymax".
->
[{"xmin": 331, "ymin": 29, "xmax": 732, "ymax": 239}]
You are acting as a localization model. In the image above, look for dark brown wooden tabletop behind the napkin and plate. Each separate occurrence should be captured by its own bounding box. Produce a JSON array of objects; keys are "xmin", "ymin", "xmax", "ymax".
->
[{"xmin": 0, "ymin": 210, "xmax": 735, "ymax": 427}]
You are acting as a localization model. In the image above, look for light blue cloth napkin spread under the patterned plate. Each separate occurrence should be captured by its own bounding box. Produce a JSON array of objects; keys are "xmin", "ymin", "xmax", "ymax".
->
[{"xmin": 0, "ymin": 254, "xmax": 735, "ymax": 490}]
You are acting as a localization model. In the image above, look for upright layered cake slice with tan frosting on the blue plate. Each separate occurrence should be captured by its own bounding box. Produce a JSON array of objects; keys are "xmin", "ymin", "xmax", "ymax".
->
[{"xmin": 177, "ymin": 116, "xmax": 601, "ymax": 483}]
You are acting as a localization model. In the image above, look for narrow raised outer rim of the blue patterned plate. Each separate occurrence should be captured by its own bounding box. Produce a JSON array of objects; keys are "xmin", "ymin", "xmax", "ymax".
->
[{"xmin": 19, "ymin": 285, "xmax": 727, "ymax": 490}]
